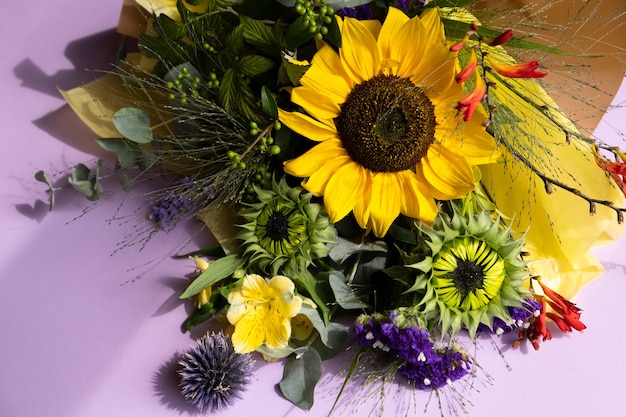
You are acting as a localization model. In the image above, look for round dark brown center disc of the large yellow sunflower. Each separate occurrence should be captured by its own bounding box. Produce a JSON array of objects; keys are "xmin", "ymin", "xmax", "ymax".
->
[{"xmin": 335, "ymin": 75, "xmax": 436, "ymax": 172}]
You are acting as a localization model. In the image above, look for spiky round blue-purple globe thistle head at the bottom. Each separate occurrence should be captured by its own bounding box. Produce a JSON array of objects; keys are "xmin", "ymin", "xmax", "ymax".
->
[{"xmin": 178, "ymin": 332, "xmax": 254, "ymax": 412}]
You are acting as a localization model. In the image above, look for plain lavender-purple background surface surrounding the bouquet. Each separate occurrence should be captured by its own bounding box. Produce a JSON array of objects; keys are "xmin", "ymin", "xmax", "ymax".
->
[{"xmin": 0, "ymin": 0, "xmax": 626, "ymax": 417}]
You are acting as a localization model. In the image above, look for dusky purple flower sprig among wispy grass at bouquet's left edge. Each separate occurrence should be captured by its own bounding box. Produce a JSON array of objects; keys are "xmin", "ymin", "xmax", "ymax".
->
[{"xmin": 148, "ymin": 177, "xmax": 217, "ymax": 230}]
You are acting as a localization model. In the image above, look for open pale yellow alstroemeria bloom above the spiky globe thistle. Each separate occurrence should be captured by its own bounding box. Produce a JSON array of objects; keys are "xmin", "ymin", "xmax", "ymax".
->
[{"xmin": 226, "ymin": 274, "xmax": 302, "ymax": 353}]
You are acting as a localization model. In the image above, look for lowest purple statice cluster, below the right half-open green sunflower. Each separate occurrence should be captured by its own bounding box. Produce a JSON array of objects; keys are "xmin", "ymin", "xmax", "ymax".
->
[{"xmin": 399, "ymin": 348, "xmax": 471, "ymax": 389}]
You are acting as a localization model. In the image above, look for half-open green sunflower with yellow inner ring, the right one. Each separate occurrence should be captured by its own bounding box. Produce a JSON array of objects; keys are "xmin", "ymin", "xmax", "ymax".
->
[{"xmin": 405, "ymin": 205, "xmax": 530, "ymax": 337}]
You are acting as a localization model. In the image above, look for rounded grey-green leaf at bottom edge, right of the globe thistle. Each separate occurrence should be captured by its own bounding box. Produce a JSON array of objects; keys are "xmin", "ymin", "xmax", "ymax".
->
[{"xmin": 278, "ymin": 349, "xmax": 322, "ymax": 410}]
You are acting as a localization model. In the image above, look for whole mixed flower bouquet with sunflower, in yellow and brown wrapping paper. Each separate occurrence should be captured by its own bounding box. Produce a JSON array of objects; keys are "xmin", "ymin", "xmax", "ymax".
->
[{"xmin": 36, "ymin": 0, "xmax": 626, "ymax": 412}]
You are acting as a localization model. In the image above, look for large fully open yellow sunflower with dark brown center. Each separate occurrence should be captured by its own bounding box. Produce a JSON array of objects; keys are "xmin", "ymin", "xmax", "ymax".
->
[{"xmin": 279, "ymin": 8, "xmax": 495, "ymax": 237}]
